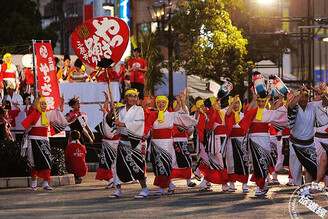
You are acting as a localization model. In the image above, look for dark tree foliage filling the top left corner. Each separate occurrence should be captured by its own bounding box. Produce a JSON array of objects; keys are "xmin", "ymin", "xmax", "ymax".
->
[{"xmin": 0, "ymin": 0, "xmax": 58, "ymax": 54}]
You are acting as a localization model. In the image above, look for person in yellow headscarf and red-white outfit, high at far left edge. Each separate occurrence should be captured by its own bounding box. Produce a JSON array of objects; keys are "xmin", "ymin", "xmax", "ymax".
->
[{"xmin": 0, "ymin": 53, "xmax": 19, "ymax": 94}]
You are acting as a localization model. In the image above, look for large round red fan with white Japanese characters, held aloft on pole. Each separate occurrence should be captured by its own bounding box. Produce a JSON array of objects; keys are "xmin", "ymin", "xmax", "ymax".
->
[{"xmin": 71, "ymin": 17, "xmax": 130, "ymax": 68}]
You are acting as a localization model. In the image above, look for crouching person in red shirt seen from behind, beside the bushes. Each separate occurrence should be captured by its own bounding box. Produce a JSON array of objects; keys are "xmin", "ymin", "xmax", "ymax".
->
[{"xmin": 65, "ymin": 130, "xmax": 88, "ymax": 184}]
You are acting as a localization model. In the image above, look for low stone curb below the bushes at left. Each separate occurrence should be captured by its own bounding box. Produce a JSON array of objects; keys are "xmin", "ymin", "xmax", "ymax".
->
[{"xmin": 0, "ymin": 174, "xmax": 75, "ymax": 189}]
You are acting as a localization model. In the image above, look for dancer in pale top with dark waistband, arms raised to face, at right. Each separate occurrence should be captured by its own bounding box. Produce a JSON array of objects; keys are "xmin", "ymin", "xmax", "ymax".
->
[{"xmin": 287, "ymin": 85, "xmax": 322, "ymax": 199}]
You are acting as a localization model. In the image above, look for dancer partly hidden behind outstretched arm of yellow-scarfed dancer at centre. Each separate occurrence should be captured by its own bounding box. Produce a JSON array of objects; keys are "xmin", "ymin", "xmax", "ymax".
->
[{"xmin": 171, "ymin": 94, "xmax": 196, "ymax": 187}]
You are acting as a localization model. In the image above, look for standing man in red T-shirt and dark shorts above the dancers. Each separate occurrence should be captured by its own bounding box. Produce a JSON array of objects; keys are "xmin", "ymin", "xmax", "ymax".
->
[{"xmin": 128, "ymin": 48, "xmax": 147, "ymax": 103}]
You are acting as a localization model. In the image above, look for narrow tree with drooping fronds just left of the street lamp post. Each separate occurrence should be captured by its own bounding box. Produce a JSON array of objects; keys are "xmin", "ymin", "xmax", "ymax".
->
[{"xmin": 139, "ymin": 31, "xmax": 165, "ymax": 95}]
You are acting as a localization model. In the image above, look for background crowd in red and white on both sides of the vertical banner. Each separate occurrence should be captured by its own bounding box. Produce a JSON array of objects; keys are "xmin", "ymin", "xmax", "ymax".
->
[{"xmin": 0, "ymin": 53, "xmax": 135, "ymax": 139}]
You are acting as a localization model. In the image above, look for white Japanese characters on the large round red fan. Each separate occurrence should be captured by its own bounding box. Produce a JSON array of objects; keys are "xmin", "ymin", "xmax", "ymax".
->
[{"xmin": 77, "ymin": 18, "xmax": 123, "ymax": 63}]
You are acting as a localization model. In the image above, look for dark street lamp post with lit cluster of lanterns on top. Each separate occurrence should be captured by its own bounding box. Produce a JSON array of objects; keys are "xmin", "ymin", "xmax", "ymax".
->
[{"xmin": 148, "ymin": 0, "xmax": 173, "ymax": 101}]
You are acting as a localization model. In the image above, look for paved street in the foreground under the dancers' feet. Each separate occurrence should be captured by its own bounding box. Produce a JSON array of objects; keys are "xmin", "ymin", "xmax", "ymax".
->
[{"xmin": 0, "ymin": 173, "xmax": 313, "ymax": 218}]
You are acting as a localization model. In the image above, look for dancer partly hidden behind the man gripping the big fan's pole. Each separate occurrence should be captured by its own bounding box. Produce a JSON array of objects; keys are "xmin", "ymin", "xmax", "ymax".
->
[{"xmin": 95, "ymin": 92, "xmax": 123, "ymax": 189}]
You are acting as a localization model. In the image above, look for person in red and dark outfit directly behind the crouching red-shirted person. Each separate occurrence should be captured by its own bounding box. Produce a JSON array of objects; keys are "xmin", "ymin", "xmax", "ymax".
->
[{"xmin": 65, "ymin": 95, "xmax": 95, "ymax": 145}]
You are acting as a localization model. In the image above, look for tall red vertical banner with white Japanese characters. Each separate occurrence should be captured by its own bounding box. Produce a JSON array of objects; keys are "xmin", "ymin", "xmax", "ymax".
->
[{"xmin": 35, "ymin": 43, "xmax": 61, "ymax": 111}]
